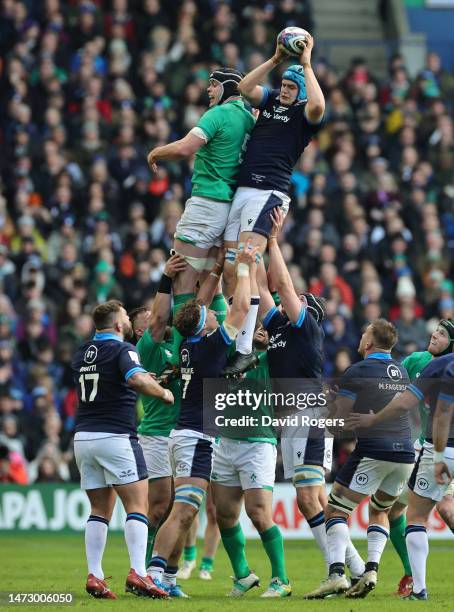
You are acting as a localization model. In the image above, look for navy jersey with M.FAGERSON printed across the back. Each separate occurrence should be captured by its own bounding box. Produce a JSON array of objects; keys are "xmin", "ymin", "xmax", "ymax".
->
[{"xmin": 339, "ymin": 353, "xmax": 415, "ymax": 463}]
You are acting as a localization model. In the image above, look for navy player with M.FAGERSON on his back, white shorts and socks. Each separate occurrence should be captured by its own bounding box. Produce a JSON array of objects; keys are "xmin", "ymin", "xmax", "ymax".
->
[{"xmin": 307, "ymin": 319, "xmax": 414, "ymax": 599}]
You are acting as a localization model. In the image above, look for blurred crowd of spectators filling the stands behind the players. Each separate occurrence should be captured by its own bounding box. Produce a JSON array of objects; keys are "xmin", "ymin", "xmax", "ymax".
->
[{"xmin": 0, "ymin": 0, "xmax": 454, "ymax": 483}]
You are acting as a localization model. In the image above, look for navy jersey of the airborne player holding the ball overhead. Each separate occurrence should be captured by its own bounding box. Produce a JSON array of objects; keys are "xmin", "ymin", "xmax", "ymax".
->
[{"xmin": 237, "ymin": 87, "xmax": 322, "ymax": 193}]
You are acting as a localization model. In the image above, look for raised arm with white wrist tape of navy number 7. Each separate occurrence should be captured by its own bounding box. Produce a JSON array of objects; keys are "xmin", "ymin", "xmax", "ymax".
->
[{"xmin": 225, "ymin": 243, "xmax": 258, "ymax": 329}]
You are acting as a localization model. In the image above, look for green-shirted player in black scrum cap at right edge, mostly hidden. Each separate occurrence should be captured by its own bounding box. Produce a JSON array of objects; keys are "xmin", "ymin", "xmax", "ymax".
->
[{"xmin": 389, "ymin": 319, "xmax": 454, "ymax": 596}]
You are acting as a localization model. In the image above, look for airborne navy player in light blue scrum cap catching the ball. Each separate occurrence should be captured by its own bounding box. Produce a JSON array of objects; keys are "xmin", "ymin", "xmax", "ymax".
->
[{"xmin": 224, "ymin": 36, "xmax": 325, "ymax": 374}]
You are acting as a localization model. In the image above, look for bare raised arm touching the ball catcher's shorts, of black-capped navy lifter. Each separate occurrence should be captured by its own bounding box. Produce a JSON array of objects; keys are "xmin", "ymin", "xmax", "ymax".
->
[{"xmin": 268, "ymin": 208, "xmax": 304, "ymax": 323}]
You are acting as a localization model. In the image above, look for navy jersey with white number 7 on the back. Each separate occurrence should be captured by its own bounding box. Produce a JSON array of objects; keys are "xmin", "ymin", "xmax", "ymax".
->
[{"xmin": 175, "ymin": 325, "xmax": 233, "ymax": 433}]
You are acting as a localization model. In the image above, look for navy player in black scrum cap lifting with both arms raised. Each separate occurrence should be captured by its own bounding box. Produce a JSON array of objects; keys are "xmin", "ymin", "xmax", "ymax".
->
[{"xmin": 258, "ymin": 208, "xmax": 364, "ymax": 588}]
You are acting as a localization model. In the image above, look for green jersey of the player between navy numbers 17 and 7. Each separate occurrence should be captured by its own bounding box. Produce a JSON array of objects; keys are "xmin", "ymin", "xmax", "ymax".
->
[{"xmin": 137, "ymin": 330, "xmax": 181, "ymax": 436}]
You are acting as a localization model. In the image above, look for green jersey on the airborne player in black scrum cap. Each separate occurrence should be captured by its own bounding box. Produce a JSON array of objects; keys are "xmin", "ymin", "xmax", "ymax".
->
[{"xmin": 192, "ymin": 100, "xmax": 255, "ymax": 202}]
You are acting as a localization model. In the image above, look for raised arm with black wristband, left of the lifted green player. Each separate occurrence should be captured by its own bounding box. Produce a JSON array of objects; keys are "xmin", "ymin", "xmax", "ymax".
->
[{"xmin": 148, "ymin": 253, "xmax": 187, "ymax": 342}]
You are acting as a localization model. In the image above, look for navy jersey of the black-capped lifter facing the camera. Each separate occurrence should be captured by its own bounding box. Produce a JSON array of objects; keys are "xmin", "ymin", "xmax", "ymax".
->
[{"xmin": 263, "ymin": 306, "xmax": 325, "ymax": 378}]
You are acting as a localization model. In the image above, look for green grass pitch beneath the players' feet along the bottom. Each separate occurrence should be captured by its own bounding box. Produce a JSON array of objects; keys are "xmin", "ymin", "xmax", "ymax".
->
[{"xmin": 0, "ymin": 534, "xmax": 454, "ymax": 612}]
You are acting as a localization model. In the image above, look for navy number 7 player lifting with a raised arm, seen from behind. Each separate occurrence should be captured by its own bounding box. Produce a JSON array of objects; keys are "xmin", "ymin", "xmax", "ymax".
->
[{"xmin": 148, "ymin": 243, "xmax": 257, "ymax": 584}]
